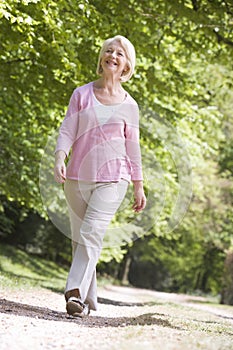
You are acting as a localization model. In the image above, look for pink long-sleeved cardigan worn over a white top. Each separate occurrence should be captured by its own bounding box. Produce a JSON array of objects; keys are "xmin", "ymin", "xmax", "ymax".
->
[{"xmin": 55, "ymin": 82, "xmax": 143, "ymax": 182}]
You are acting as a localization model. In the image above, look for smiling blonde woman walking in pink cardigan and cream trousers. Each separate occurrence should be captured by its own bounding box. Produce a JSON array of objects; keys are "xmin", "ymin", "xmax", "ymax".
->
[{"xmin": 54, "ymin": 35, "xmax": 146, "ymax": 317}]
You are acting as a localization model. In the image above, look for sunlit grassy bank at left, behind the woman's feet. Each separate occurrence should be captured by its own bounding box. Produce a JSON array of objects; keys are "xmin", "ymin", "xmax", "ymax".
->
[{"xmin": 0, "ymin": 244, "xmax": 67, "ymax": 292}]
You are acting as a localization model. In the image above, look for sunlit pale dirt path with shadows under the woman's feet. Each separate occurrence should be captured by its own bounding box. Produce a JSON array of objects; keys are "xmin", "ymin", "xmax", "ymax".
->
[{"xmin": 0, "ymin": 286, "xmax": 233, "ymax": 350}]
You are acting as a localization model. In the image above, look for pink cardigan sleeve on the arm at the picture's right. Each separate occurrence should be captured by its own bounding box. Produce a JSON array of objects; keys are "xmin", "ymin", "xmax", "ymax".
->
[{"xmin": 125, "ymin": 107, "xmax": 143, "ymax": 181}]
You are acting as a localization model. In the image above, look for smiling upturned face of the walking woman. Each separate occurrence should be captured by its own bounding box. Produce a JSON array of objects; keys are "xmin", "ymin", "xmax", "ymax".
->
[{"xmin": 101, "ymin": 41, "xmax": 128, "ymax": 76}]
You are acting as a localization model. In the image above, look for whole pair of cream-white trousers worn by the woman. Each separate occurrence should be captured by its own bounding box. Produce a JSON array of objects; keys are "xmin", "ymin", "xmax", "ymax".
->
[{"xmin": 64, "ymin": 179, "xmax": 128, "ymax": 310}]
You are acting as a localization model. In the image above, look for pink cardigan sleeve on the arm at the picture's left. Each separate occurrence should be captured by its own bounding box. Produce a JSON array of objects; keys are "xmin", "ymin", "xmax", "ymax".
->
[{"xmin": 55, "ymin": 91, "xmax": 78, "ymax": 156}]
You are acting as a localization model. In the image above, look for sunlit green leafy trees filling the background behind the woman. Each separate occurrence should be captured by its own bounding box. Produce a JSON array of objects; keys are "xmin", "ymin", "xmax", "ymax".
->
[{"xmin": 0, "ymin": 0, "xmax": 233, "ymax": 304}]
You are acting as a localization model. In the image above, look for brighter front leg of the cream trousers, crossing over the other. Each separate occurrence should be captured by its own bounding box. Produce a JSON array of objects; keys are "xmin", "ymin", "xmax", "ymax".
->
[{"xmin": 66, "ymin": 180, "xmax": 128, "ymax": 310}]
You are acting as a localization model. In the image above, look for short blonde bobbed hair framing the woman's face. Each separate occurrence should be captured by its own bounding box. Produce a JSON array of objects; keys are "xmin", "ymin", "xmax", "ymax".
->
[{"xmin": 96, "ymin": 35, "xmax": 136, "ymax": 82}]
